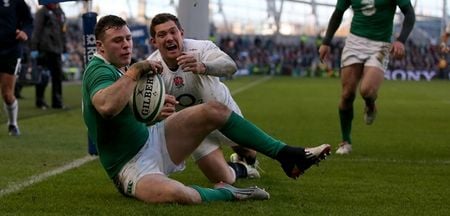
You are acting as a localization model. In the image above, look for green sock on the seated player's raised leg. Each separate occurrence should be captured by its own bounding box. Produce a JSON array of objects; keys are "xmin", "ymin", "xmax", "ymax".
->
[{"xmin": 219, "ymin": 112, "xmax": 286, "ymax": 158}]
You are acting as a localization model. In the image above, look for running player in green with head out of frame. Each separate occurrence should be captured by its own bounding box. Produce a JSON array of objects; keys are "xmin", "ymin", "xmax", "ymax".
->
[{"xmin": 319, "ymin": 0, "xmax": 415, "ymax": 154}]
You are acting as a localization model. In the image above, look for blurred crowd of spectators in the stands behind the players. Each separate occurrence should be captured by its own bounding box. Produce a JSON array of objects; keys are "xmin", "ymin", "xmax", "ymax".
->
[{"xmin": 57, "ymin": 21, "xmax": 447, "ymax": 78}]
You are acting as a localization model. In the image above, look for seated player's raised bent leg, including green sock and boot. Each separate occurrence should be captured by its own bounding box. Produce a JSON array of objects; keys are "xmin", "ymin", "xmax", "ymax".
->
[{"xmin": 165, "ymin": 102, "xmax": 329, "ymax": 178}]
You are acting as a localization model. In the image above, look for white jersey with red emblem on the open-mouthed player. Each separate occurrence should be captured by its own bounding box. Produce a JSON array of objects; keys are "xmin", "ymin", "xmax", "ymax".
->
[{"xmin": 148, "ymin": 39, "xmax": 240, "ymax": 113}]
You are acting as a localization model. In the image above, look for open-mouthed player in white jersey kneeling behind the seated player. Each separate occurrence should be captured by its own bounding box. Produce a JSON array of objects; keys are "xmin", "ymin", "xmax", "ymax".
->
[{"xmin": 148, "ymin": 13, "xmax": 260, "ymax": 184}]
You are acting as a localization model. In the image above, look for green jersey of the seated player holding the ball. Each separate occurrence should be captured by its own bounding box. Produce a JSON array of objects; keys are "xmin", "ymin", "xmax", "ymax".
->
[{"xmin": 82, "ymin": 56, "xmax": 149, "ymax": 178}]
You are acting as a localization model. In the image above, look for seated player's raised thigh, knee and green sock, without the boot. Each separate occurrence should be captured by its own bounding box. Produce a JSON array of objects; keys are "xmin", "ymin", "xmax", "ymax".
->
[{"xmin": 165, "ymin": 102, "xmax": 286, "ymax": 164}]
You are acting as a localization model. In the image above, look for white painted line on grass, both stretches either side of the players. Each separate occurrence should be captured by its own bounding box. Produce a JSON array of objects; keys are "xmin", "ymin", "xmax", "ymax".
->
[{"xmin": 0, "ymin": 77, "xmax": 271, "ymax": 198}]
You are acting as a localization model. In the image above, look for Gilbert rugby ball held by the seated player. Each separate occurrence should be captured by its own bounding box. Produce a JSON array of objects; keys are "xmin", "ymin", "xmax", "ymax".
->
[{"xmin": 129, "ymin": 73, "xmax": 165, "ymax": 124}]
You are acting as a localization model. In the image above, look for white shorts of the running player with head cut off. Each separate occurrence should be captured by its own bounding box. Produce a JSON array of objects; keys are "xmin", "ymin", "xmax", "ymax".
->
[{"xmin": 341, "ymin": 34, "xmax": 391, "ymax": 71}]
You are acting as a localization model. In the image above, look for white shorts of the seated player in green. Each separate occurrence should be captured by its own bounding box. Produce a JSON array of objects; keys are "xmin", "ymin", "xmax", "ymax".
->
[{"xmin": 114, "ymin": 121, "xmax": 185, "ymax": 197}]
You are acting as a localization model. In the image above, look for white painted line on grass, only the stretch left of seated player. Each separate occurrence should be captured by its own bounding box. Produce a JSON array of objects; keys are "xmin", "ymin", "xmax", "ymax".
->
[{"xmin": 0, "ymin": 155, "xmax": 97, "ymax": 197}]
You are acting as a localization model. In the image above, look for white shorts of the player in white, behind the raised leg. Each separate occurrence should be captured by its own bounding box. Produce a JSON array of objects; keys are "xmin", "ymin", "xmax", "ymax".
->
[{"xmin": 192, "ymin": 94, "xmax": 242, "ymax": 161}]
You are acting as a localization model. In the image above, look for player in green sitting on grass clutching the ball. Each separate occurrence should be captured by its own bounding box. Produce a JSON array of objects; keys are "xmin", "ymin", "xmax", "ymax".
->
[{"xmin": 82, "ymin": 15, "xmax": 330, "ymax": 204}]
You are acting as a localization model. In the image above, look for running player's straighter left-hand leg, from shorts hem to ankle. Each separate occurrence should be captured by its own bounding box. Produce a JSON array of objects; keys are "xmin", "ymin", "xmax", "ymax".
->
[{"xmin": 339, "ymin": 64, "xmax": 363, "ymax": 144}]
